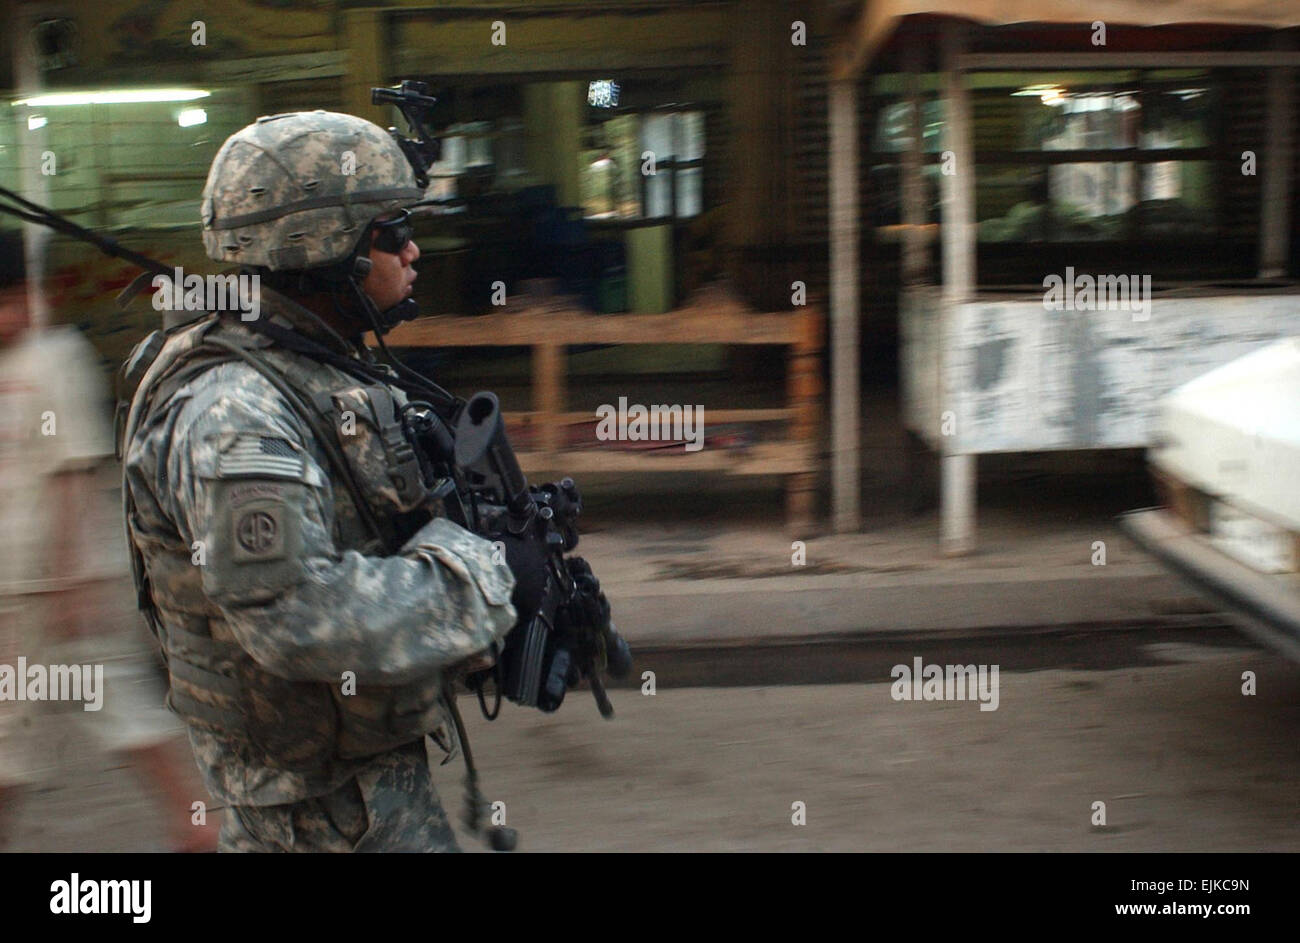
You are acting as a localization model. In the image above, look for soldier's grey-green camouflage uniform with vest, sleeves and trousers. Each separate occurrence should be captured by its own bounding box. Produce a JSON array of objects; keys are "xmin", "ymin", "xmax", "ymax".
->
[{"xmin": 124, "ymin": 113, "xmax": 515, "ymax": 851}]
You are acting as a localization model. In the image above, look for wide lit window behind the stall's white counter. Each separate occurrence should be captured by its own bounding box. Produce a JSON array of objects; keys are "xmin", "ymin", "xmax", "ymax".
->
[{"xmin": 871, "ymin": 70, "xmax": 1221, "ymax": 242}]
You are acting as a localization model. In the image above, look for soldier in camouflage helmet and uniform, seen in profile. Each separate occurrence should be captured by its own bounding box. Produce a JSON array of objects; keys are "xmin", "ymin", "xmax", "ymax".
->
[{"xmin": 124, "ymin": 112, "xmax": 529, "ymax": 851}]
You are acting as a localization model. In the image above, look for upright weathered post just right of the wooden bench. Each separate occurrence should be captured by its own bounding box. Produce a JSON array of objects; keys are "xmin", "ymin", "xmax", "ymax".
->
[{"xmin": 829, "ymin": 78, "xmax": 862, "ymax": 533}]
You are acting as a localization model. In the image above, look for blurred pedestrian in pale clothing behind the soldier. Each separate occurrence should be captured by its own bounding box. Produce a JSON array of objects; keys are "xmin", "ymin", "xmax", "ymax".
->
[{"xmin": 0, "ymin": 233, "xmax": 216, "ymax": 851}]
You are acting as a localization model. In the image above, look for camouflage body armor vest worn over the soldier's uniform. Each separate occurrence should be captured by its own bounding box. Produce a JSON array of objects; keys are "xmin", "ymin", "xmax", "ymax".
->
[{"xmin": 120, "ymin": 317, "xmax": 446, "ymax": 770}]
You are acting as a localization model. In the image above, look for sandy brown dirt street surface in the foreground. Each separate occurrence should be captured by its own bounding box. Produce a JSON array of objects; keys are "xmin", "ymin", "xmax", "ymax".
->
[{"xmin": 9, "ymin": 645, "xmax": 1300, "ymax": 852}]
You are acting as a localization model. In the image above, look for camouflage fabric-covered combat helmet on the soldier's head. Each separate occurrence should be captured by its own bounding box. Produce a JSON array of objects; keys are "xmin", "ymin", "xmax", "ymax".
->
[{"xmin": 202, "ymin": 111, "xmax": 424, "ymax": 272}]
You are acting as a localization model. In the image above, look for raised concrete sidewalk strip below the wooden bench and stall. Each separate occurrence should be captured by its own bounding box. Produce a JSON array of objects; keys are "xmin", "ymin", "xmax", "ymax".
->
[{"xmin": 579, "ymin": 510, "xmax": 1210, "ymax": 645}]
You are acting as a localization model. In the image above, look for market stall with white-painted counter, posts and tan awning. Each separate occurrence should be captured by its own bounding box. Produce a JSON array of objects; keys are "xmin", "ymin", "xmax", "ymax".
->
[{"xmin": 831, "ymin": 0, "xmax": 1300, "ymax": 543}]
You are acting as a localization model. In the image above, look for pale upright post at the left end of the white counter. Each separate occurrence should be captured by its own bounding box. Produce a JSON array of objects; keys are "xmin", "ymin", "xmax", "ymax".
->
[{"xmin": 939, "ymin": 23, "xmax": 976, "ymax": 555}]
